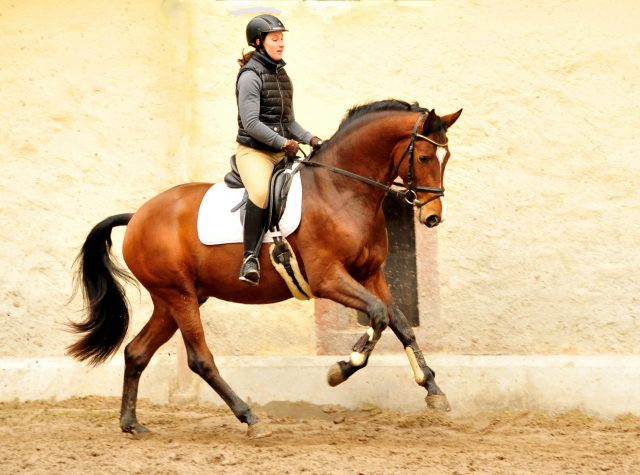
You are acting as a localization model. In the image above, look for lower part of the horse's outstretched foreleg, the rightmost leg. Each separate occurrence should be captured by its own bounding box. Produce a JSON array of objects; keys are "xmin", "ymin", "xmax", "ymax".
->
[{"xmin": 389, "ymin": 299, "xmax": 451, "ymax": 412}]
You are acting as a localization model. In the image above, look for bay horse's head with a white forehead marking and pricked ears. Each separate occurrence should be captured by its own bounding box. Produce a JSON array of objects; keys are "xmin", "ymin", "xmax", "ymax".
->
[{"xmin": 399, "ymin": 109, "xmax": 462, "ymax": 228}]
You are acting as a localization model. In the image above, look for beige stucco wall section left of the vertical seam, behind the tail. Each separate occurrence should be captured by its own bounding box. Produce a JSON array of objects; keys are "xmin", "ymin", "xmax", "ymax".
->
[{"xmin": 0, "ymin": 0, "xmax": 185, "ymax": 357}]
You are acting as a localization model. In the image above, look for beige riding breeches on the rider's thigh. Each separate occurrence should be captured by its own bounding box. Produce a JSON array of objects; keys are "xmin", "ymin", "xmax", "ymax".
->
[{"xmin": 236, "ymin": 144, "xmax": 284, "ymax": 209}]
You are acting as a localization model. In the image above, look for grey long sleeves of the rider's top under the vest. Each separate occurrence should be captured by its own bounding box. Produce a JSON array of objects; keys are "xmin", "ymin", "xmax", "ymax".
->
[{"xmin": 238, "ymin": 71, "xmax": 313, "ymax": 149}]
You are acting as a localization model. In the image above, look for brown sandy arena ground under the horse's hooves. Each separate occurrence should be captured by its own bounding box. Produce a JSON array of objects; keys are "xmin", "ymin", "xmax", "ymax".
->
[{"xmin": 0, "ymin": 397, "xmax": 640, "ymax": 475}]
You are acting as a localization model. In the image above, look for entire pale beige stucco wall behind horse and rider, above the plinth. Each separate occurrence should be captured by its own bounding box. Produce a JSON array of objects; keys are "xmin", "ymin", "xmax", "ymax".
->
[{"xmin": 0, "ymin": 0, "xmax": 640, "ymax": 357}]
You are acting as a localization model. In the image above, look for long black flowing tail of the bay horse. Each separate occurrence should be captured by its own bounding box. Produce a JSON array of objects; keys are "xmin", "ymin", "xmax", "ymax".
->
[{"xmin": 67, "ymin": 213, "xmax": 135, "ymax": 366}]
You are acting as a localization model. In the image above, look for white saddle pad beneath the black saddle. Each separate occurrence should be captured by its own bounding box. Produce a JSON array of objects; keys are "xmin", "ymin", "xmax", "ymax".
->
[{"xmin": 198, "ymin": 169, "xmax": 302, "ymax": 245}]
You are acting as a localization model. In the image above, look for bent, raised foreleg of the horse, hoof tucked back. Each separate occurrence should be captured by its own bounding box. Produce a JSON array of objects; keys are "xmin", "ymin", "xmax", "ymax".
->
[{"xmin": 320, "ymin": 269, "xmax": 389, "ymax": 386}]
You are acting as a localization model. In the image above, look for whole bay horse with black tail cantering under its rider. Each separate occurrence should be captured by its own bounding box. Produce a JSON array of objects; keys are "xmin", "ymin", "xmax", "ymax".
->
[{"xmin": 67, "ymin": 100, "xmax": 462, "ymax": 438}]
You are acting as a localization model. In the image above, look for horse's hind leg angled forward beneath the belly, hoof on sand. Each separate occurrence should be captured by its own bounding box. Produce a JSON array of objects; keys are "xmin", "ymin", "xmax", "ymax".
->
[{"xmin": 166, "ymin": 294, "xmax": 273, "ymax": 439}]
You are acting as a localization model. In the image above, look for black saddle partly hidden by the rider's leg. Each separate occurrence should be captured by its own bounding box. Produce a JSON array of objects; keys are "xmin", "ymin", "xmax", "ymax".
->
[{"xmin": 224, "ymin": 155, "xmax": 294, "ymax": 232}]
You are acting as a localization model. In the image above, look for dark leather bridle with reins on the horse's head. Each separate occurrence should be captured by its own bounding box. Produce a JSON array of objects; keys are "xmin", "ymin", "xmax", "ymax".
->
[{"xmin": 294, "ymin": 114, "xmax": 448, "ymax": 209}]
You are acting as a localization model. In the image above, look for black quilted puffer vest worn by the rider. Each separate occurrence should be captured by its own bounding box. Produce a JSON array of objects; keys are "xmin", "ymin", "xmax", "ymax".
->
[{"xmin": 236, "ymin": 52, "xmax": 293, "ymax": 152}]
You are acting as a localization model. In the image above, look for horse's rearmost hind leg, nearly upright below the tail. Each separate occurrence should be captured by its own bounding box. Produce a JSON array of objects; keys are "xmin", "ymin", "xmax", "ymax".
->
[{"xmin": 120, "ymin": 302, "xmax": 178, "ymax": 434}]
